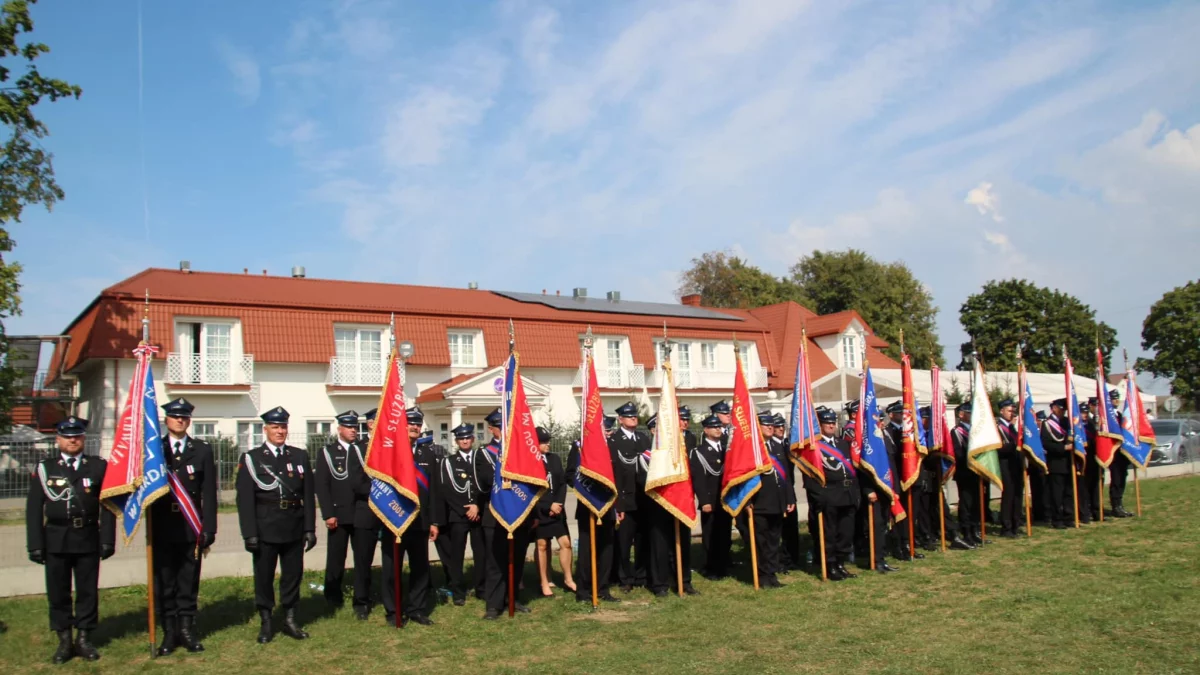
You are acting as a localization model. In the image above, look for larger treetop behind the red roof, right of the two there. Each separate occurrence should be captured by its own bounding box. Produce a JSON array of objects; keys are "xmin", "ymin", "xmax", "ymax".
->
[{"xmin": 791, "ymin": 249, "xmax": 943, "ymax": 368}]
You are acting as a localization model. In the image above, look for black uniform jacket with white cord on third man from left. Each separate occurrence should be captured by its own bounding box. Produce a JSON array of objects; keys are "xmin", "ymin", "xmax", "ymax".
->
[{"xmin": 235, "ymin": 443, "xmax": 317, "ymax": 544}]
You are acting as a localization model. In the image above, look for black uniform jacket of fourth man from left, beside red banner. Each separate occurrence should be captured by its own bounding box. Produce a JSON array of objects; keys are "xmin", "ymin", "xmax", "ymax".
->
[{"xmin": 313, "ymin": 438, "xmax": 378, "ymax": 527}]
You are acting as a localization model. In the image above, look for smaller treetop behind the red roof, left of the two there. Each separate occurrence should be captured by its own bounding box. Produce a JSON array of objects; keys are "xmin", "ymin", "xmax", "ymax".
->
[{"xmin": 676, "ymin": 251, "xmax": 803, "ymax": 310}]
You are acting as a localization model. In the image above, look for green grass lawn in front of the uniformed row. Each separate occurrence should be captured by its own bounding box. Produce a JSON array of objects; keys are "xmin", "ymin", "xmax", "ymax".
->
[{"xmin": 0, "ymin": 477, "xmax": 1200, "ymax": 675}]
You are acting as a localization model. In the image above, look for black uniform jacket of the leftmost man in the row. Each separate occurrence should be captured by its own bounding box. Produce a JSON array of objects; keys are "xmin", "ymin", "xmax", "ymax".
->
[{"xmin": 25, "ymin": 452, "xmax": 116, "ymax": 554}]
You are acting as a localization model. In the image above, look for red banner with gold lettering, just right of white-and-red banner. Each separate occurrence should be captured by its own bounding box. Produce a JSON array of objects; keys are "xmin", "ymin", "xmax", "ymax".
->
[{"xmin": 721, "ymin": 359, "xmax": 772, "ymax": 516}]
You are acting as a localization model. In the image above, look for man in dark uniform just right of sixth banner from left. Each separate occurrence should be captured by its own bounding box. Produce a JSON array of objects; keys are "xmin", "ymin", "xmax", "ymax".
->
[{"xmin": 742, "ymin": 412, "xmax": 796, "ymax": 589}]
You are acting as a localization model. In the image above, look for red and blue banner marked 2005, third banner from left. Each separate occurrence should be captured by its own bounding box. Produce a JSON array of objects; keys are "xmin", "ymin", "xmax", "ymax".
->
[{"xmin": 488, "ymin": 352, "xmax": 550, "ymax": 534}]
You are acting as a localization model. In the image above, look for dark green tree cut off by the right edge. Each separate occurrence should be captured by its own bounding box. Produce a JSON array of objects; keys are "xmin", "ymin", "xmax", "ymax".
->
[{"xmin": 1138, "ymin": 281, "xmax": 1200, "ymax": 408}]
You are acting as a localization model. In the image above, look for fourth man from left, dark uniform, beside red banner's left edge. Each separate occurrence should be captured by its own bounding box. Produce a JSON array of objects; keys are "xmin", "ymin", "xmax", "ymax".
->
[{"xmin": 314, "ymin": 411, "xmax": 379, "ymax": 621}]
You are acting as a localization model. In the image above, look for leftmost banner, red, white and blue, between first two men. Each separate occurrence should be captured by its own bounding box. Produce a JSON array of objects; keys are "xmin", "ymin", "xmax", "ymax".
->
[{"xmin": 100, "ymin": 344, "xmax": 170, "ymax": 546}]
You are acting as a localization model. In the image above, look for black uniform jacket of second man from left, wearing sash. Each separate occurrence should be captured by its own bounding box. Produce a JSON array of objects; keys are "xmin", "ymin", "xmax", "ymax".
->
[{"xmin": 150, "ymin": 436, "xmax": 217, "ymax": 544}]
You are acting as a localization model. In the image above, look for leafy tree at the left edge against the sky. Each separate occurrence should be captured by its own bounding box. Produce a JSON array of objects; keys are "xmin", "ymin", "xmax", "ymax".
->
[{"xmin": 0, "ymin": 0, "xmax": 83, "ymax": 429}]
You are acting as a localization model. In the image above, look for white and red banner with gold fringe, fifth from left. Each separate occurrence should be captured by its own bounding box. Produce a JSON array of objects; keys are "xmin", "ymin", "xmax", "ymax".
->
[{"xmin": 646, "ymin": 363, "xmax": 696, "ymax": 530}]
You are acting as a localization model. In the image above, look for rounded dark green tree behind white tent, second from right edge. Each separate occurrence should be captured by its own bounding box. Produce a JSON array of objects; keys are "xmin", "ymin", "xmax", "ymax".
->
[{"xmin": 959, "ymin": 279, "xmax": 1117, "ymax": 376}]
